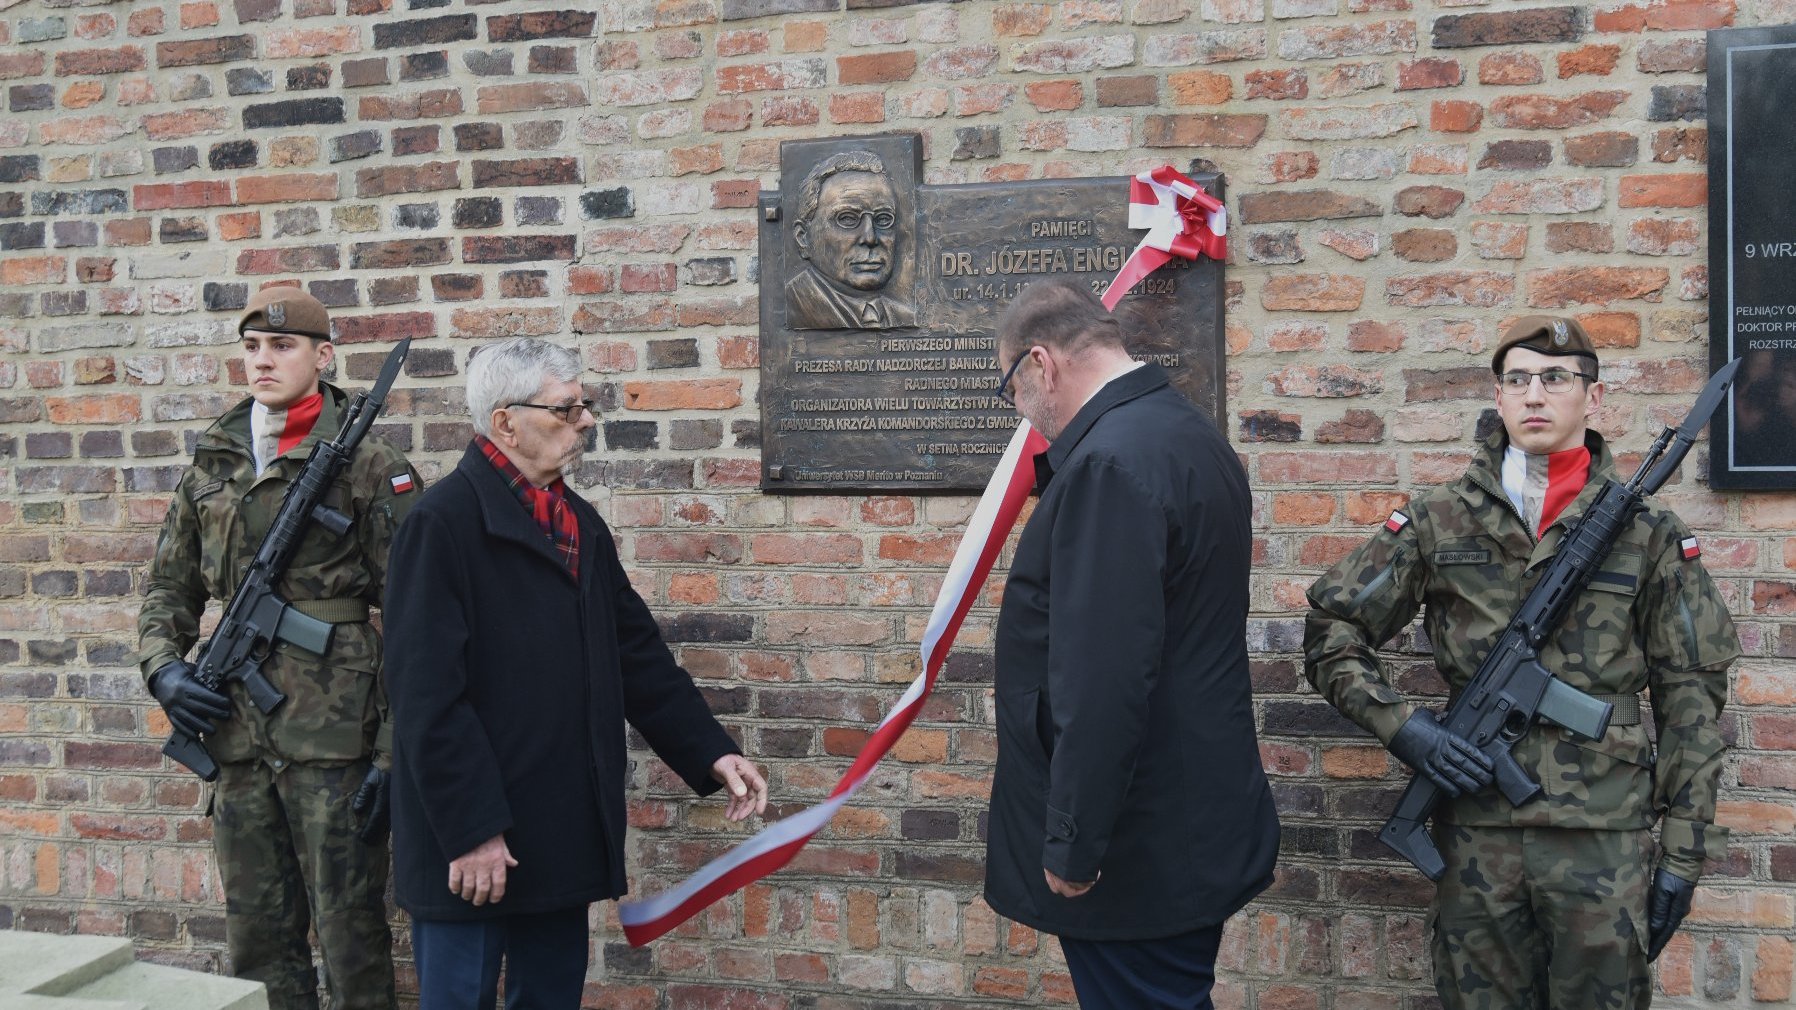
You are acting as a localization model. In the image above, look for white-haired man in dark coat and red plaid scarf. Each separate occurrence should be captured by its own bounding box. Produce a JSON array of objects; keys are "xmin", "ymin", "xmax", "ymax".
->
[{"xmin": 386, "ymin": 338, "xmax": 767, "ymax": 1010}]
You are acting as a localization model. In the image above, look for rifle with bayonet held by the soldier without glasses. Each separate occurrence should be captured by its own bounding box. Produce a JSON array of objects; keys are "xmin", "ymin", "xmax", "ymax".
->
[{"xmin": 162, "ymin": 336, "xmax": 411, "ymax": 782}]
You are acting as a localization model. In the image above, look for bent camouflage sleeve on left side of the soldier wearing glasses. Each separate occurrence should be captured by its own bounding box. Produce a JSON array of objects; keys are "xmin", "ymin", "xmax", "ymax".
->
[{"xmin": 1304, "ymin": 512, "xmax": 1426, "ymax": 746}]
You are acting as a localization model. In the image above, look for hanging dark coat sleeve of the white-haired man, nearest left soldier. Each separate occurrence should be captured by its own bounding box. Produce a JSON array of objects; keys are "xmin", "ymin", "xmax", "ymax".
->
[{"xmin": 384, "ymin": 512, "xmax": 512, "ymax": 861}]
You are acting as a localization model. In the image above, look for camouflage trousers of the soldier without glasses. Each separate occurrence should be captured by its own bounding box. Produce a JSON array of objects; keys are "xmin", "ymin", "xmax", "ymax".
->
[{"xmin": 212, "ymin": 760, "xmax": 395, "ymax": 1010}]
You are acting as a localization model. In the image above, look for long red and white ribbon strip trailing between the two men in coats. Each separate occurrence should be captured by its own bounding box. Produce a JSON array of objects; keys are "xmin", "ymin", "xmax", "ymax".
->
[{"xmin": 618, "ymin": 421, "xmax": 1047, "ymax": 947}]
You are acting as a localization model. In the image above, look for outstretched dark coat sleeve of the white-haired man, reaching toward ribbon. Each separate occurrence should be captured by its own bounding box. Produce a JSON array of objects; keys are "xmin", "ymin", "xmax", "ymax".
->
[{"xmin": 600, "ymin": 525, "xmax": 742, "ymax": 796}]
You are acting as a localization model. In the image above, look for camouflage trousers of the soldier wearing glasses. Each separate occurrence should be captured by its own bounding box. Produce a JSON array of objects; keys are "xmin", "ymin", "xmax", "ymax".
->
[{"xmin": 1433, "ymin": 825, "xmax": 1652, "ymax": 1010}]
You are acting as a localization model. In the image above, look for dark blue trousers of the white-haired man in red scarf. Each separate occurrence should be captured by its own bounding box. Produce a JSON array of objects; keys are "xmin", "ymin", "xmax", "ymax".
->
[{"xmin": 411, "ymin": 906, "xmax": 587, "ymax": 1010}]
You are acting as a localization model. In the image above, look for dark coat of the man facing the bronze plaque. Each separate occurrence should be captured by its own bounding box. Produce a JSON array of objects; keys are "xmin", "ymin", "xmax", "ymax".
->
[{"xmin": 986, "ymin": 365, "xmax": 1279, "ymax": 940}]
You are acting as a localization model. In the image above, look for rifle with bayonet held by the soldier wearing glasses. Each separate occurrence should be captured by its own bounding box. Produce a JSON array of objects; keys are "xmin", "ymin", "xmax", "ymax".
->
[{"xmin": 1378, "ymin": 358, "xmax": 1740, "ymax": 881}]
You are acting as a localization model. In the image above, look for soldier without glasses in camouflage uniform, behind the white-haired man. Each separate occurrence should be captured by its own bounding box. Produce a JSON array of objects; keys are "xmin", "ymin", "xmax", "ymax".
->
[{"xmin": 138, "ymin": 288, "xmax": 422, "ymax": 1010}]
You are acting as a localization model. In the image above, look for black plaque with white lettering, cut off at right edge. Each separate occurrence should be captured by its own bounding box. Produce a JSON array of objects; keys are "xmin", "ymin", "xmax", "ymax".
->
[{"xmin": 1708, "ymin": 25, "xmax": 1796, "ymax": 491}]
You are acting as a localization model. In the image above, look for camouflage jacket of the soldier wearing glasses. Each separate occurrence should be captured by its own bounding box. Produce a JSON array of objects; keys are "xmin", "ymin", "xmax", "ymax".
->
[{"xmin": 1304, "ymin": 431, "xmax": 1740, "ymax": 881}]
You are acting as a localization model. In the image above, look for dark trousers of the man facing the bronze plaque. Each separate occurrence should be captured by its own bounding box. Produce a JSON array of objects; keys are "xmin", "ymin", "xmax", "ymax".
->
[{"xmin": 1056, "ymin": 924, "xmax": 1223, "ymax": 1010}]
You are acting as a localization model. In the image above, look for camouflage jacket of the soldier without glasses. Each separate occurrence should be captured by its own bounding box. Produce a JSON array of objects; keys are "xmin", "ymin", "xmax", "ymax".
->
[{"xmin": 136, "ymin": 385, "xmax": 424, "ymax": 762}]
